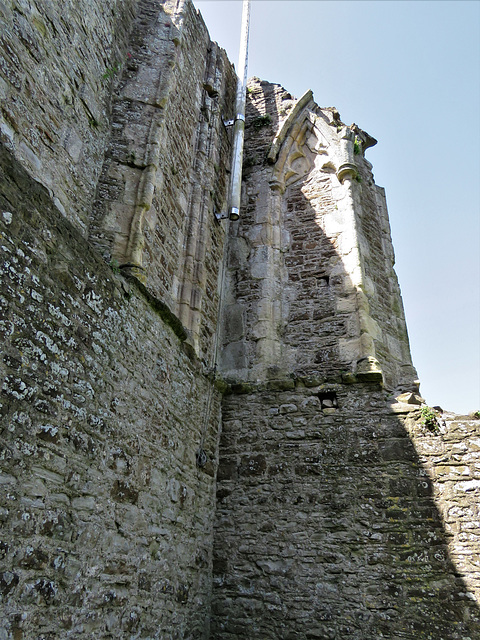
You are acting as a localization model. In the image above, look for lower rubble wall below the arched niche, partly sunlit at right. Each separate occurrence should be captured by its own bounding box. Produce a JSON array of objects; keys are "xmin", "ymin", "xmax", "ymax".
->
[{"xmin": 211, "ymin": 381, "xmax": 480, "ymax": 640}]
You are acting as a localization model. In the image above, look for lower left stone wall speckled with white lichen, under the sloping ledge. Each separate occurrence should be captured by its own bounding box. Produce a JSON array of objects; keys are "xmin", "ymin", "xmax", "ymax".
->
[{"xmin": 0, "ymin": 139, "xmax": 220, "ymax": 639}]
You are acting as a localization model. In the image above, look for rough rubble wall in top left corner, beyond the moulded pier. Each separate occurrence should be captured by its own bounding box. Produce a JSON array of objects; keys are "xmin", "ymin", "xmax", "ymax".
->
[{"xmin": 0, "ymin": 0, "xmax": 137, "ymax": 234}]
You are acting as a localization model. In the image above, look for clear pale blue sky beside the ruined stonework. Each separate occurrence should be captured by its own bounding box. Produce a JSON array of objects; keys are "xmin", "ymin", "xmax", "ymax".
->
[{"xmin": 195, "ymin": 0, "xmax": 480, "ymax": 413}]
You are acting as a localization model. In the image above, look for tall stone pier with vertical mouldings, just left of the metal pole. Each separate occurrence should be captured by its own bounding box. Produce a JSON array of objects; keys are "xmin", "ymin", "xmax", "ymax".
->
[{"xmin": 90, "ymin": 0, "xmax": 235, "ymax": 359}]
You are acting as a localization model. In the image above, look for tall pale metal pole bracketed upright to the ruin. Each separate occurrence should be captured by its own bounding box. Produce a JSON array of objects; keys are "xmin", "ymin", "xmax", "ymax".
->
[{"xmin": 229, "ymin": 0, "xmax": 250, "ymax": 220}]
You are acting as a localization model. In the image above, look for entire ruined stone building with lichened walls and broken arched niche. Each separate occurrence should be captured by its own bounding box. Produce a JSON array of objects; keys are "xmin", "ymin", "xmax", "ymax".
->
[{"xmin": 0, "ymin": 0, "xmax": 480, "ymax": 640}]
